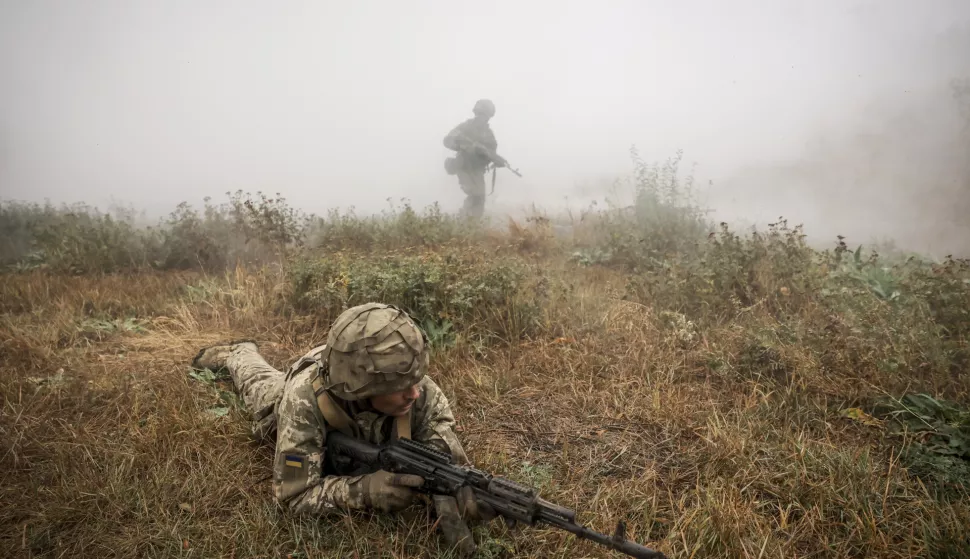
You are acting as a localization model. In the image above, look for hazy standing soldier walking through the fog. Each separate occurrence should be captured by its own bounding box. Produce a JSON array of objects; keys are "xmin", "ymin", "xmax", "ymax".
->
[{"xmin": 444, "ymin": 99, "xmax": 505, "ymax": 217}]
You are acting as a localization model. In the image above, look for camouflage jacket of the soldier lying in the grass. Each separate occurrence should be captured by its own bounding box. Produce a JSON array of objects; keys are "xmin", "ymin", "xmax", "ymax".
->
[{"xmin": 273, "ymin": 350, "xmax": 468, "ymax": 513}]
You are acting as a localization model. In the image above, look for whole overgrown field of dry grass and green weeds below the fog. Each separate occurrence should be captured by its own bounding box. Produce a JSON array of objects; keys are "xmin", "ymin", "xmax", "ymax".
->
[{"xmin": 0, "ymin": 160, "xmax": 970, "ymax": 559}]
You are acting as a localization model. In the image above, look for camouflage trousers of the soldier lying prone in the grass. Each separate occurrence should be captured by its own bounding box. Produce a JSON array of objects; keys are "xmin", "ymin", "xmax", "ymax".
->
[{"xmin": 226, "ymin": 345, "xmax": 286, "ymax": 440}]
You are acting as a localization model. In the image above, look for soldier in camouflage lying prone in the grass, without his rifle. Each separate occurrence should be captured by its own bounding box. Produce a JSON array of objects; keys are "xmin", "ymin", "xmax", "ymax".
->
[{"xmin": 192, "ymin": 303, "xmax": 495, "ymax": 556}]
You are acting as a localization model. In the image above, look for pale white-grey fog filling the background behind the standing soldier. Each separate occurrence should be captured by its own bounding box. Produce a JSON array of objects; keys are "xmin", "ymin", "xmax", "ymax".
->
[{"xmin": 0, "ymin": 0, "xmax": 970, "ymax": 254}]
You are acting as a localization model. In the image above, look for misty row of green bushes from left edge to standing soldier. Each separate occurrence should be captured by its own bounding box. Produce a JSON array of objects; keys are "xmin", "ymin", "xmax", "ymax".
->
[{"xmin": 0, "ymin": 191, "xmax": 496, "ymax": 274}]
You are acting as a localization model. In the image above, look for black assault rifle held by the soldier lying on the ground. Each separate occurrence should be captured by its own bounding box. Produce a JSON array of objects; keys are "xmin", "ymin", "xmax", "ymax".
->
[{"xmin": 326, "ymin": 431, "xmax": 666, "ymax": 559}]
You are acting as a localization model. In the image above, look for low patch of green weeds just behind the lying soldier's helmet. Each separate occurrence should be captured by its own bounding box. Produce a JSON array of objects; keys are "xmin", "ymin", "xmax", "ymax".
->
[{"xmin": 289, "ymin": 251, "xmax": 546, "ymax": 346}]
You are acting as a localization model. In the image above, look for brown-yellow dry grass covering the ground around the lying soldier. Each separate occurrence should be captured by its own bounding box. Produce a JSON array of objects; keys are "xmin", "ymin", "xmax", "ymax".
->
[{"xmin": 0, "ymin": 228, "xmax": 970, "ymax": 559}]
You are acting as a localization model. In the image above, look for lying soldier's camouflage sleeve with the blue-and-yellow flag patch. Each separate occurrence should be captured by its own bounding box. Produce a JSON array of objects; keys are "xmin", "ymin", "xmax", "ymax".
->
[{"xmin": 273, "ymin": 371, "xmax": 364, "ymax": 514}]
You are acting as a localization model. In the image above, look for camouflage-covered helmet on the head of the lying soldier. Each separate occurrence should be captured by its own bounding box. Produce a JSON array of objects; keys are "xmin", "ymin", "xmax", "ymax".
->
[{"xmin": 320, "ymin": 303, "xmax": 428, "ymax": 400}]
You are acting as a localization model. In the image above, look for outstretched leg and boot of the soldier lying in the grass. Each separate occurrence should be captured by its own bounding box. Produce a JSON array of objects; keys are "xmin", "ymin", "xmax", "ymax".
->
[{"xmin": 192, "ymin": 342, "xmax": 284, "ymax": 413}]
